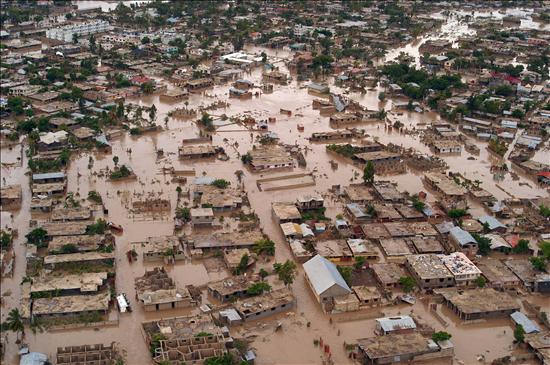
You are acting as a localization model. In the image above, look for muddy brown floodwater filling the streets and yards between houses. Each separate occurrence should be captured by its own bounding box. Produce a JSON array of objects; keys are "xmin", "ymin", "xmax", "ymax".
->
[{"xmin": 1, "ymin": 7, "xmax": 548, "ymax": 364}]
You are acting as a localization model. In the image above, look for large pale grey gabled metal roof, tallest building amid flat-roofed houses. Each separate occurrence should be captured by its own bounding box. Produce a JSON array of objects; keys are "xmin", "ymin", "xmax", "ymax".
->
[{"xmin": 303, "ymin": 255, "xmax": 351, "ymax": 295}]
